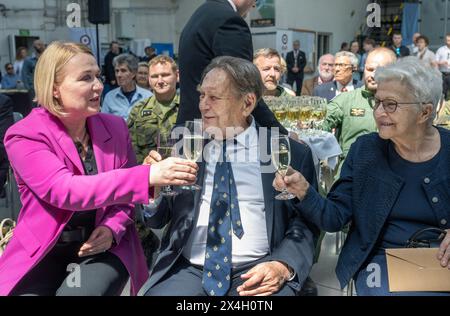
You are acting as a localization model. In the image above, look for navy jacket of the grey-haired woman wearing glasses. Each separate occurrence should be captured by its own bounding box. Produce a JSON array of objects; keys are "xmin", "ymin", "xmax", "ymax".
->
[{"xmin": 298, "ymin": 128, "xmax": 450, "ymax": 288}]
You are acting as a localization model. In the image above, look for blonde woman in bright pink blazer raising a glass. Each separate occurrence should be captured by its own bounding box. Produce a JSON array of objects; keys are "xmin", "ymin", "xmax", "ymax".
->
[{"xmin": 0, "ymin": 42, "xmax": 197, "ymax": 295}]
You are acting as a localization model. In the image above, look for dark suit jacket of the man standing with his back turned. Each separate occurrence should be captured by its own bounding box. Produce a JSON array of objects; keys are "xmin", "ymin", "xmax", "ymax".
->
[{"xmin": 177, "ymin": 0, "xmax": 287, "ymax": 133}]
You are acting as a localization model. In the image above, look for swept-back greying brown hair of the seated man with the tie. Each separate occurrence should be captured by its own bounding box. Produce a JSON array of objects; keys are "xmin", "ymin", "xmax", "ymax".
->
[{"xmin": 200, "ymin": 56, "xmax": 264, "ymax": 101}]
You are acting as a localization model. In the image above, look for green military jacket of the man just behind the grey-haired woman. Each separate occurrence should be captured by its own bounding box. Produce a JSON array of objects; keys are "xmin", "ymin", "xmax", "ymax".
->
[{"xmin": 322, "ymin": 87, "xmax": 377, "ymax": 158}]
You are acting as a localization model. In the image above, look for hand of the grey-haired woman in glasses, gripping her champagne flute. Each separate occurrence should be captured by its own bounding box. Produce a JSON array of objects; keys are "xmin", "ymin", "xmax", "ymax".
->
[{"xmin": 273, "ymin": 167, "xmax": 309, "ymax": 201}]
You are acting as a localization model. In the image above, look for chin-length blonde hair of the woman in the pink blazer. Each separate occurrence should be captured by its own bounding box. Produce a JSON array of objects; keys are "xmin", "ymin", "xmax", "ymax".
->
[{"xmin": 34, "ymin": 41, "xmax": 94, "ymax": 116}]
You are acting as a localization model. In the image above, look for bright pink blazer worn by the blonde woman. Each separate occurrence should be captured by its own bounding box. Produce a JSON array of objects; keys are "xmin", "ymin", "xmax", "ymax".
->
[{"xmin": 0, "ymin": 108, "xmax": 150, "ymax": 295}]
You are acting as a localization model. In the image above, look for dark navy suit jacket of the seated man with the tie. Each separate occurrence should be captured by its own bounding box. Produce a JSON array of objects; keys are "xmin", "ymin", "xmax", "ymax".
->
[{"xmin": 143, "ymin": 129, "xmax": 318, "ymax": 296}]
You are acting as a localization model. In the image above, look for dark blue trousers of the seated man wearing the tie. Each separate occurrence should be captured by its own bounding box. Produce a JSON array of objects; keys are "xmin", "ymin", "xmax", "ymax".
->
[{"xmin": 145, "ymin": 256, "xmax": 295, "ymax": 296}]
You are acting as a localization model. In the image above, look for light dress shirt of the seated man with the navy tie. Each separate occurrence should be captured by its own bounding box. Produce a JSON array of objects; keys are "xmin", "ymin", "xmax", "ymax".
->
[{"xmin": 183, "ymin": 118, "xmax": 269, "ymax": 267}]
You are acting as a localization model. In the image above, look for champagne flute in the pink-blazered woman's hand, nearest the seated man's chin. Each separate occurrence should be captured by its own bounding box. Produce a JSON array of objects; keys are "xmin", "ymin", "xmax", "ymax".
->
[{"xmin": 182, "ymin": 121, "xmax": 203, "ymax": 191}]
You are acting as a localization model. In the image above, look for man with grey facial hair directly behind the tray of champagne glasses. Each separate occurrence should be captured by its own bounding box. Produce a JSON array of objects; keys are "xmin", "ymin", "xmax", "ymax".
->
[{"xmin": 253, "ymin": 48, "xmax": 295, "ymax": 97}]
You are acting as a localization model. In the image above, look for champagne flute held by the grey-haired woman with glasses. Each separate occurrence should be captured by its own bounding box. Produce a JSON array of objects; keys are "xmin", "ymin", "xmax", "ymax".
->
[{"xmin": 270, "ymin": 135, "xmax": 295, "ymax": 200}]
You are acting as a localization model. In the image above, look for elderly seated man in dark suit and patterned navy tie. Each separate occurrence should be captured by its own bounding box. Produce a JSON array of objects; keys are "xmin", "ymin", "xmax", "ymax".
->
[{"xmin": 142, "ymin": 56, "xmax": 316, "ymax": 296}]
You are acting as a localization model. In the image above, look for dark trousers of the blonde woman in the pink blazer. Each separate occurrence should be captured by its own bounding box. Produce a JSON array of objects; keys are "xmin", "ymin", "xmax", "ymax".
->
[{"xmin": 11, "ymin": 243, "xmax": 128, "ymax": 296}]
